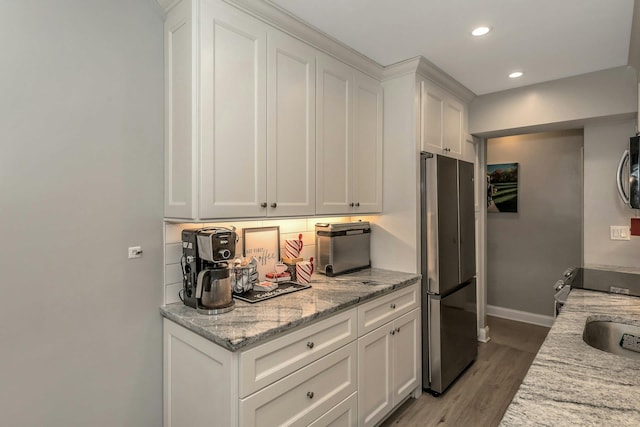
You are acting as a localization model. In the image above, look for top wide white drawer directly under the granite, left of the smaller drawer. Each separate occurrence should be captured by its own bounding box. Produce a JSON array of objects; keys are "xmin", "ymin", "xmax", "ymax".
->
[{"xmin": 239, "ymin": 308, "xmax": 357, "ymax": 397}]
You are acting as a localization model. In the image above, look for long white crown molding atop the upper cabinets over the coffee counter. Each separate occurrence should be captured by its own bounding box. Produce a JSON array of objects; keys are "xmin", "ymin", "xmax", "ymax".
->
[{"xmin": 226, "ymin": 0, "xmax": 384, "ymax": 80}]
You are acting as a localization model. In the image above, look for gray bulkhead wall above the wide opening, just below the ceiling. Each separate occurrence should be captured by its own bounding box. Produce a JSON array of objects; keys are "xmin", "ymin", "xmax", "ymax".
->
[{"xmin": 469, "ymin": 67, "xmax": 638, "ymax": 137}]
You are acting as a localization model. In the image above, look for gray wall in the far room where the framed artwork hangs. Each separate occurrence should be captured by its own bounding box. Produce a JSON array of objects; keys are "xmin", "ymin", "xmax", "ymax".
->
[{"xmin": 487, "ymin": 130, "xmax": 583, "ymax": 316}]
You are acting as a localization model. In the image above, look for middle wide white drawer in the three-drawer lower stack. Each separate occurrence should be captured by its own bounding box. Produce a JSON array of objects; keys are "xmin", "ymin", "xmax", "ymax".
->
[{"xmin": 240, "ymin": 342, "xmax": 357, "ymax": 427}]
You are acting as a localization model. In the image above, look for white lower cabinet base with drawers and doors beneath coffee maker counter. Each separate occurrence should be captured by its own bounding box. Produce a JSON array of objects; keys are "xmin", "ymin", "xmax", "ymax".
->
[{"xmin": 163, "ymin": 283, "xmax": 420, "ymax": 427}]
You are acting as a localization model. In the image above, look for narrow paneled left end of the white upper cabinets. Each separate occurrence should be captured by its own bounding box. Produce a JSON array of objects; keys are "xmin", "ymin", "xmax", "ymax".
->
[{"xmin": 164, "ymin": 1, "xmax": 196, "ymax": 218}]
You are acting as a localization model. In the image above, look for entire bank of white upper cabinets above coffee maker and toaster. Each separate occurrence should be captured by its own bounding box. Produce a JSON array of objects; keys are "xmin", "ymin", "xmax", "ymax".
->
[{"xmin": 164, "ymin": 0, "xmax": 382, "ymax": 220}]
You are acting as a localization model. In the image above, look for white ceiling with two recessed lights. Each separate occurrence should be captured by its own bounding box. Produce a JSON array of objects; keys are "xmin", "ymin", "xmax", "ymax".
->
[{"xmin": 271, "ymin": 0, "xmax": 634, "ymax": 95}]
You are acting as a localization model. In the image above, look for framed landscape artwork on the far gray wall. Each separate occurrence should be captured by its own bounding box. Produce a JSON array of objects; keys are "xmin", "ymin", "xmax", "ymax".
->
[{"xmin": 487, "ymin": 163, "xmax": 518, "ymax": 213}]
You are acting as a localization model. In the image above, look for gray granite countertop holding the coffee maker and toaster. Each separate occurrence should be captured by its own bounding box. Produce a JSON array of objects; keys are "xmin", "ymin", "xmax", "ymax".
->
[{"xmin": 160, "ymin": 268, "xmax": 420, "ymax": 351}]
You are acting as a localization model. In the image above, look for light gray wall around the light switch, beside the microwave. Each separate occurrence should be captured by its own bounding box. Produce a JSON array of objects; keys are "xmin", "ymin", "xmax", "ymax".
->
[{"xmin": 584, "ymin": 120, "xmax": 640, "ymax": 270}]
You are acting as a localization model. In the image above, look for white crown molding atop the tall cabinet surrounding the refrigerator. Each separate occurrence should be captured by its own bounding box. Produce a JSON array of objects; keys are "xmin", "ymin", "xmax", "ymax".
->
[{"xmin": 383, "ymin": 56, "xmax": 476, "ymax": 104}]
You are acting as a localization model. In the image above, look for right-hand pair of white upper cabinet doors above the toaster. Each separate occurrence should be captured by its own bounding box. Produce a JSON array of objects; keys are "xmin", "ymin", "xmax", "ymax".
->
[{"xmin": 316, "ymin": 55, "xmax": 382, "ymax": 214}]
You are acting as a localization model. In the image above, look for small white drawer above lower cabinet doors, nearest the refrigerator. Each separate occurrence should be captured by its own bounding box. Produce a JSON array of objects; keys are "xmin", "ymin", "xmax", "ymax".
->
[{"xmin": 358, "ymin": 282, "xmax": 420, "ymax": 337}]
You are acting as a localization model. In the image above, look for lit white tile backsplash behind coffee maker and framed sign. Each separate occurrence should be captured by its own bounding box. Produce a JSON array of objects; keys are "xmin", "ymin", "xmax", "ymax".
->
[{"xmin": 164, "ymin": 216, "xmax": 376, "ymax": 304}]
